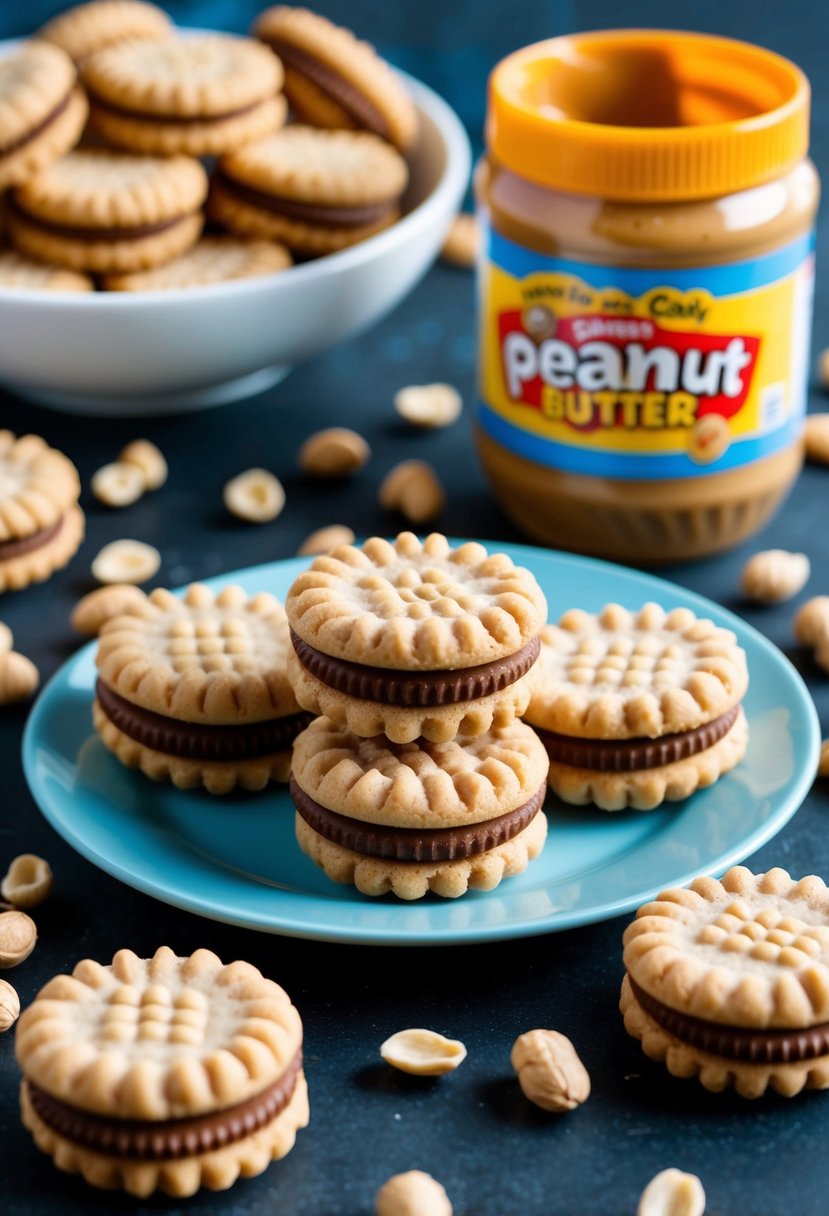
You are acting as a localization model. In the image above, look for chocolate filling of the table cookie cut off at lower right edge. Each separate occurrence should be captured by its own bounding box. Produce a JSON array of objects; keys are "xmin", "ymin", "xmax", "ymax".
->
[{"xmin": 627, "ymin": 973, "xmax": 829, "ymax": 1064}]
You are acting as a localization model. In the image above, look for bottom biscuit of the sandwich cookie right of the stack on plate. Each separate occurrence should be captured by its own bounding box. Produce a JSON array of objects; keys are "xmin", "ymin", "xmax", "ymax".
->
[{"xmin": 548, "ymin": 709, "xmax": 749, "ymax": 811}]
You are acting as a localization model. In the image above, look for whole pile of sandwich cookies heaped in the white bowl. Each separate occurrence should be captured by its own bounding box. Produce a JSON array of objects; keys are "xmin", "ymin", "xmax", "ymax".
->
[{"xmin": 0, "ymin": 0, "xmax": 417, "ymax": 292}]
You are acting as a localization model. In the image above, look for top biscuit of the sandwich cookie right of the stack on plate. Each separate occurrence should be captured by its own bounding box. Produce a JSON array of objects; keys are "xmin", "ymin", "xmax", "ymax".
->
[{"xmin": 526, "ymin": 603, "xmax": 749, "ymax": 739}]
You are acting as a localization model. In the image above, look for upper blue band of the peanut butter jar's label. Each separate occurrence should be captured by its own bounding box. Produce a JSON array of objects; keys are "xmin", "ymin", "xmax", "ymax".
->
[{"xmin": 487, "ymin": 229, "xmax": 814, "ymax": 295}]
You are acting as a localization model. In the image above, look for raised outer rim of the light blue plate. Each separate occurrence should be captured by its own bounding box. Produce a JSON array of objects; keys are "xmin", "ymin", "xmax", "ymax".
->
[{"xmin": 21, "ymin": 537, "xmax": 822, "ymax": 947}]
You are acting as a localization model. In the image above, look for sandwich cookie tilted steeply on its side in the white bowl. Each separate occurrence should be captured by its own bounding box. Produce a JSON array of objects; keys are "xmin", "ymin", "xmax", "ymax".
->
[{"xmin": 253, "ymin": 5, "xmax": 417, "ymax": 152}]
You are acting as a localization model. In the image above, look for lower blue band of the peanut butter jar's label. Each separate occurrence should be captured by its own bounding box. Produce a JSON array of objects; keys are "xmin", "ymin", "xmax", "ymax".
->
[{"xmin": 478, "ymin": 401, "xmax": 803, "ymax": 482}]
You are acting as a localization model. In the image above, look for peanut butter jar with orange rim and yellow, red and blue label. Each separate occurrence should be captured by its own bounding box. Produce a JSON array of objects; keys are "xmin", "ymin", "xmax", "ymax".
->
[{"xmin": 475, "ymin": 30, "xmax": 819, "ymax": 562}]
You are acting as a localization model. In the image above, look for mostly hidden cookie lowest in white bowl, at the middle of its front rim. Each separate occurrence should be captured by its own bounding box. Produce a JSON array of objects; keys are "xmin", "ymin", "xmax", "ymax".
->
[{"xmin": 102, "ymin": 236, "xmax": 292, "ymax": 292}]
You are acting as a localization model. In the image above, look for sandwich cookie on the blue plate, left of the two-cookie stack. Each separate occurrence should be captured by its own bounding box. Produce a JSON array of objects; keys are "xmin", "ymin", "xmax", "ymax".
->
[{"xmin": 92, "ymin": 584, "xmax": 309, "ymax": 794}]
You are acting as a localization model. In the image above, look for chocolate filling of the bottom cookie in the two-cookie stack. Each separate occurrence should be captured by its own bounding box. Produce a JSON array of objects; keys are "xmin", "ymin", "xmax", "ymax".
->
[{"xmin": 291, "ymin": 777, "xmax": 546, "ymax": 862}]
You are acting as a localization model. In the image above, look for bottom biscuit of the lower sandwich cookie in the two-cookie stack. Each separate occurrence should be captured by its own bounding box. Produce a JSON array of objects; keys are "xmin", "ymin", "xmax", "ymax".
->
[{"xmin": 295, "ymin": 810, "xmax": 547, "ymax": 900}]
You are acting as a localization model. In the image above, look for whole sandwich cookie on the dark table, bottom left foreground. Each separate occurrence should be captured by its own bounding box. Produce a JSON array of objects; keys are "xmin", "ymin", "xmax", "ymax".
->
[{"xmin": 16, "ymin": 946, "xmax": 309, "ymax": 1198}]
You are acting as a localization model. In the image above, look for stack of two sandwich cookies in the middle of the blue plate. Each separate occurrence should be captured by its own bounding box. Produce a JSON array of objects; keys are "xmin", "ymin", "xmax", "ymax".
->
[{"xmin": 286, "ymin": 533, "xmax": 547, "ymax": 899}]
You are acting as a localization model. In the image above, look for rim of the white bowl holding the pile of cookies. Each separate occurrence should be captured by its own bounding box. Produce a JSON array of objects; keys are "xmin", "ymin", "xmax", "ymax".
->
[{"xmin": 0, "ymin": 36, "xmax": 472, "ymax": 313}]
